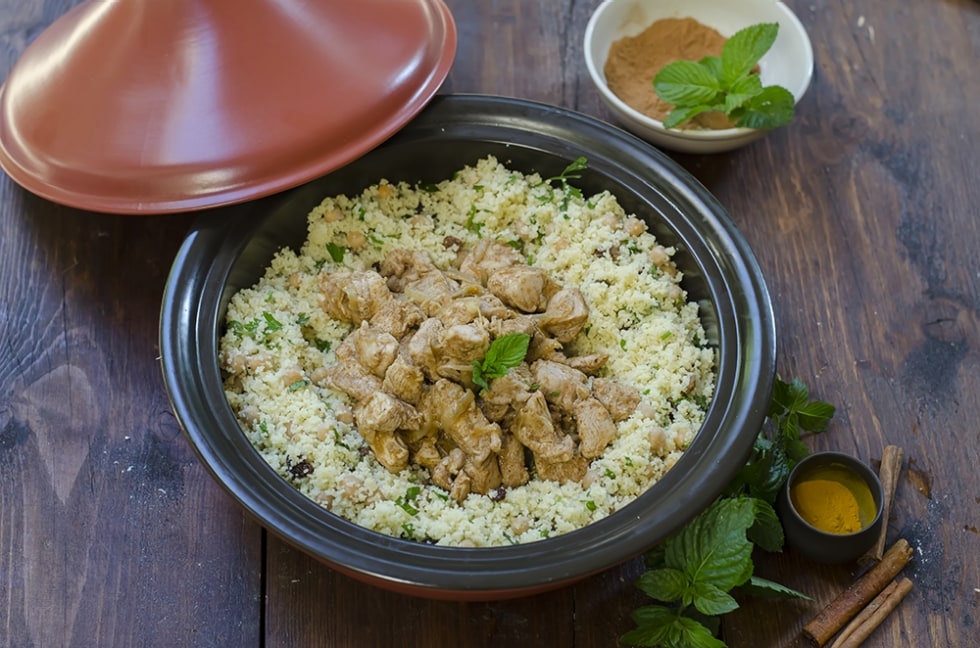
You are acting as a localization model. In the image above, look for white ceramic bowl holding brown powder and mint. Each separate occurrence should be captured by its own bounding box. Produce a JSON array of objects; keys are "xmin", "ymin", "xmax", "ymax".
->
[{"xmin": 585, "ymin": 0, "xmax": 813, "ymax": 153}]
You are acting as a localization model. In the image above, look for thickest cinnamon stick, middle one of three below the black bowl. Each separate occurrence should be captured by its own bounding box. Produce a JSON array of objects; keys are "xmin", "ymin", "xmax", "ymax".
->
[{"xmin": 803, "ymin": 538, "xmax": 912, "ymax": 646}]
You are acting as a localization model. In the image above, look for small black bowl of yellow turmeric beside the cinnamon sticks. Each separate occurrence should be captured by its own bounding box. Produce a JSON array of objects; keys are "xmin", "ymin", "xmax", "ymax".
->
[{"xmin": 778, "ymin": 452, "xmax": 885, "ymax": 564}]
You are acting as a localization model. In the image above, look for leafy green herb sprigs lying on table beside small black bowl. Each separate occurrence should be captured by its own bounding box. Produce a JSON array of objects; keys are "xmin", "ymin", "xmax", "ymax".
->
[{"xmin": 620, "ymin": 376, "xmax": 835, "ymax": 648}]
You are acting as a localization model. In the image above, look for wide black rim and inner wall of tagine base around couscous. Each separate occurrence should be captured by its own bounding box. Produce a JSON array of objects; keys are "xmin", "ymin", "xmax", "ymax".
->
[{"xmin": 159, "ymin": 95, "xmax": 776, "ymax": 600}]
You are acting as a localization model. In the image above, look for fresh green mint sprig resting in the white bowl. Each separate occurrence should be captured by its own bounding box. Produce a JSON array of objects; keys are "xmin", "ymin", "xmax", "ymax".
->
[{"xmin": 653, "ymin": 23, "xmax": 795, "ymax": 129}]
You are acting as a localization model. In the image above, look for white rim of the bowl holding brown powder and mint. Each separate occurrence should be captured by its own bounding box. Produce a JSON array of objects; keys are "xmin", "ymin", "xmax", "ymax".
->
[{"xmin": 583, "ymin": 0, "xmax": 814, "ymax": 144}]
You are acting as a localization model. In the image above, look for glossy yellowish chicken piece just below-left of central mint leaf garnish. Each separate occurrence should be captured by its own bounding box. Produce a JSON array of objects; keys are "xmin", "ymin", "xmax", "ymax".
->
[{"xmin": 419, "ymin": 379, "xmax": 501, "ymax": 462}]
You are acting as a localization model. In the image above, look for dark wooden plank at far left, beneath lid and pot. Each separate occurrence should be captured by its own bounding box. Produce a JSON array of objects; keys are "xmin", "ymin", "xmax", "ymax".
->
[{"xmin": 0, "ymin": 0, "xmax": 261, "ymax": 648}]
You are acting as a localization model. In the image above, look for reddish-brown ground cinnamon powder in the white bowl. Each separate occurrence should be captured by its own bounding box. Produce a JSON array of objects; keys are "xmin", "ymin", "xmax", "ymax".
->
[{"xmin": 604, "ymin": 18, "xmax": 732, "ymax": 128}]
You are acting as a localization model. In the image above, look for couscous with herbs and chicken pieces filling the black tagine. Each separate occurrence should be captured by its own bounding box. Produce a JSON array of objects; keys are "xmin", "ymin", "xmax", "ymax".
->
[{"xmin": 220, "ymin": 157, "xmax": 715, "ymax": 547}]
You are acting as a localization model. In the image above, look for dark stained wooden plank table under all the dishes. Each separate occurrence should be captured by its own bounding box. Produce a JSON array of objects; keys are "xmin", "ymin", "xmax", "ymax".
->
[{"xmin": 0, "ymin": 0, "xmax": 980, "ymax": 648}]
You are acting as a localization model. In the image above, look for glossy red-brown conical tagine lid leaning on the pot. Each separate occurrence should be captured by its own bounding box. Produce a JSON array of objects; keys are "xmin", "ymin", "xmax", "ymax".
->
[{"xmin": 0, "ymin": 0, "xmax": 456, "ymax": 214}]
